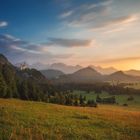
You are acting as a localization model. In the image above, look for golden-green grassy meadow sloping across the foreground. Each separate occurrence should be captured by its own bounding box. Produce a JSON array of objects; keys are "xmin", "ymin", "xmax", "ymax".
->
[{"xmin": 0, "ymin": 99, "xmax": 140, "ymax": 140}]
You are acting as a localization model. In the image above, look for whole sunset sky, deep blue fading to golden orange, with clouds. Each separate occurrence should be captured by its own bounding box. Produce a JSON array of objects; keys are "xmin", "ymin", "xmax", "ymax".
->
[{"xmin": 0, "ymin": 0, "xmax": 140, "ymax": 70}]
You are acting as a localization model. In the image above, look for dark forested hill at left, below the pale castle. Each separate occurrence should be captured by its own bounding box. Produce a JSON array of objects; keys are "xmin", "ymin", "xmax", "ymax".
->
[{"xmin": 0, "ymin": 54, "xmax": 52, "ymax": 100}]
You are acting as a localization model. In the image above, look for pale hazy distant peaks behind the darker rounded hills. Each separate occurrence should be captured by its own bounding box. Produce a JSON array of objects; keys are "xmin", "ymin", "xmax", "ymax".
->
[{"xmin": 15, "ymin": 62, "xmax": 140, "ymax": 77}]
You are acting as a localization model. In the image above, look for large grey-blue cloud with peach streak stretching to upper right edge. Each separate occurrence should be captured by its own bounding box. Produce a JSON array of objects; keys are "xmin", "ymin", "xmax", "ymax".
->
[{"xmin": 61, "ymin": 0, "xmax": 139, "ymax": 30}]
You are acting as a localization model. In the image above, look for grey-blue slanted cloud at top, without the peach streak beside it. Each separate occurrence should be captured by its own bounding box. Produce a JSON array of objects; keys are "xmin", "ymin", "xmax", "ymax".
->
[{"xmin": 61, "ymin": 0, "xmax": 112, "ymax": 27}]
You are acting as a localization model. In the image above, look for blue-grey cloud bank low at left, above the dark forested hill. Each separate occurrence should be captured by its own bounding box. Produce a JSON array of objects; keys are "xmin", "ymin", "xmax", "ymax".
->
[{"xmin": 0, "ymin": 35, "xmax": 72, "ymax": 63}]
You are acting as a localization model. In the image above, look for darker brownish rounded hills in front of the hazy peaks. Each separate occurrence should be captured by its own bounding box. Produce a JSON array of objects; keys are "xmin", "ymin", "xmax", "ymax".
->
[{"xmin": 52, "ymin": 67, "xmax": 140, "ymax": 83}]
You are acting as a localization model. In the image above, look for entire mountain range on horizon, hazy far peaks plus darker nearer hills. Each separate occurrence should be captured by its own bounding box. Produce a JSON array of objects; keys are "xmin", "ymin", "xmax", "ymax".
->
[{"xmin": 13, "ymin": 60, "xmax": 140, "ymax": 82}]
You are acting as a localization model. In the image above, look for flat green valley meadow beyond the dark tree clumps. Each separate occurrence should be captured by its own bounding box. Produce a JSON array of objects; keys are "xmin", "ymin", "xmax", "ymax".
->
[{"xmin": 73, "ymin": 91, "xmax": 140, "ymax": 107}]
